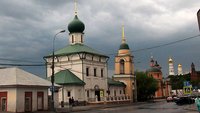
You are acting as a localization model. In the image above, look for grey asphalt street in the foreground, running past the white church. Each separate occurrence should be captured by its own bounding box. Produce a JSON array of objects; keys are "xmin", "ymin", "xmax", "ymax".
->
[{"xmin": 72, "ymin": 102, "xmax": 197, "ymax": 113}]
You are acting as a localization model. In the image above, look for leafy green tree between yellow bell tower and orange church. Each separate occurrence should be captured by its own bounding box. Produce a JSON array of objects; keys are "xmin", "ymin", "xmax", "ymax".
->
[{"xmin": 135, "ymin": 72, "xmax": 158, "ymax": 101}]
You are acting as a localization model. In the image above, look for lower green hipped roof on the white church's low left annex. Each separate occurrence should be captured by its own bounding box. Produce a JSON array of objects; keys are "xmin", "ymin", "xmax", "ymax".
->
[{"xmin": 48, "ymin": 69, "xmax": 85, "ymax": 85}]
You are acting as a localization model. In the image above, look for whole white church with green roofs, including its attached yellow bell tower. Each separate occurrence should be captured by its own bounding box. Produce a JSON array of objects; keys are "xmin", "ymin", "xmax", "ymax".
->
[{"xmin": 44, "ymin": 3, "xmax": 133, "ymax": 106}]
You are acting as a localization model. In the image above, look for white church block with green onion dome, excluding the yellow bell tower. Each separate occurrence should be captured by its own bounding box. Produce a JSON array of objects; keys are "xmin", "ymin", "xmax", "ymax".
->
[{"xmin": 44, "ymin": 2, "xmax": 109, "ymax": 102}]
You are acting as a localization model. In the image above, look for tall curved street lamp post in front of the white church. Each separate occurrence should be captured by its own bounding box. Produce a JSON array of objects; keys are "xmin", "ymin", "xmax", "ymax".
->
[{"xmin": 51, "ymin": 30, "xmax": 65, "ymax": 111}]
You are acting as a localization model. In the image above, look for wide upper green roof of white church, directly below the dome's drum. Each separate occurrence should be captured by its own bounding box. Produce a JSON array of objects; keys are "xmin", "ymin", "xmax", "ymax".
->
[{"xmin": 46, "ymin": 43, "xmax": 108, "ymax": 57}]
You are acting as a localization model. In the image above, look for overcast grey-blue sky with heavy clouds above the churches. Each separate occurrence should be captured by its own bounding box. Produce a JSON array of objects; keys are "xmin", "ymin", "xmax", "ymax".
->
[{"xmin": 0, "ymin": 0, "xmax": 200, "ymax": 77}]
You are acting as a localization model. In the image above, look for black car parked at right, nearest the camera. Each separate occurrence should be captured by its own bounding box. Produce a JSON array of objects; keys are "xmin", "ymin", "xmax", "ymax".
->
[{"xmin": 175, "ymin": 96, "xmax": 195, "ymax": 105}]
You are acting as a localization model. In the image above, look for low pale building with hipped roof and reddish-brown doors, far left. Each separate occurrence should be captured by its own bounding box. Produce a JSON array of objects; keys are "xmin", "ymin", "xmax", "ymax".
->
[{"xmin": 0, "ymin": 68, "xmax": 51, "ymax": 112}]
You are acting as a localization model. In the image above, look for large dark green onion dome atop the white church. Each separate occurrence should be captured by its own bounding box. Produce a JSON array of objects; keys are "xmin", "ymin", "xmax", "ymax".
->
[{"xmin": 68, "ymin": 15, "xmax": 85, "ymax": 33}]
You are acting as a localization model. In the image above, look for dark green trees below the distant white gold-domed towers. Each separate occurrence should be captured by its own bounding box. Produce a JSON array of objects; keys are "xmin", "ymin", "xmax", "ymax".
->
[{"xmin": 168, "ymin": 74, "xmax": 190, "ymax": 90}]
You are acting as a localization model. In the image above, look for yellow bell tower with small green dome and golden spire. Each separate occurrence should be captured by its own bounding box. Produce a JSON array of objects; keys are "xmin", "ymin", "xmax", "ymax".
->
[{"xmin": 114, "ymin": 26, "xmax": 136, "ymax": 101}]
